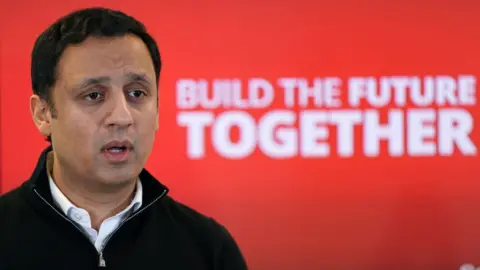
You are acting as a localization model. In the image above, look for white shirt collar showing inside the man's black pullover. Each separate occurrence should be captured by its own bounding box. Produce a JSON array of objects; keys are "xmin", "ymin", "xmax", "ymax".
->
[{"xmin": 49, "ymin": 174, "xmax": 143, "ymax": 252}]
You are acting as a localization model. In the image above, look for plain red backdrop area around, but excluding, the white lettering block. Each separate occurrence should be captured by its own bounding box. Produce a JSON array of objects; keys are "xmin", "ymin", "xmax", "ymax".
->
[{"xmin": 0, "ymin": 0, "xmax": 480, "ymax": 270}]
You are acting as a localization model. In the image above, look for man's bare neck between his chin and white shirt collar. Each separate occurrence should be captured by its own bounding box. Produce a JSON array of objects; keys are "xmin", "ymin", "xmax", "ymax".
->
[{"xmin": 47, "ymin": 153, "xmax": 136, "ymax": 230}]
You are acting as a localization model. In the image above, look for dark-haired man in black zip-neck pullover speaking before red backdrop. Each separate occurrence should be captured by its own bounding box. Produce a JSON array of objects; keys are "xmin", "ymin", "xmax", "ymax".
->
[{"xmin": 0, "ymin": 8, "xmax": 247, "ymax": 270}]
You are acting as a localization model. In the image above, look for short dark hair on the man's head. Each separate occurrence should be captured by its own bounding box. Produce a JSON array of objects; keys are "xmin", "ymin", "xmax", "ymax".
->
[{"xmin": 31, "ymin": 7, "xmax": 162, "ymax": 142}]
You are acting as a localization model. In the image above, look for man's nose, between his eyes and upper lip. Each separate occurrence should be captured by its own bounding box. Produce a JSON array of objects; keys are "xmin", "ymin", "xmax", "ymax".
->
[{"xmin": 106, "ymin": 91, "xmax": 133, "ymax": 128}]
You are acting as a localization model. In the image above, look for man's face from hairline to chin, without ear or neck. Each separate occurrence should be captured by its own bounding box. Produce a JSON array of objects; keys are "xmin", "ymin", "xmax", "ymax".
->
[{"xmin": 42, "ymin": 35, "xmax": 158, "ymax": 187}]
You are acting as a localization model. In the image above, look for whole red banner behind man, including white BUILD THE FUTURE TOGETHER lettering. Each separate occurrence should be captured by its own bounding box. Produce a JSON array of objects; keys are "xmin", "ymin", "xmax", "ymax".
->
[{"xmin": 0, "ymin": 0, "xmax": 480, "ymax": 270}]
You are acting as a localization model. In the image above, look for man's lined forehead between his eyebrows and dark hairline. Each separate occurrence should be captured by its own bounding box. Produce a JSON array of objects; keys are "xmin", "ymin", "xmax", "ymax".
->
[{"xmin": 57, "ymin": 35, "xmax": 155, "ymax": 85}]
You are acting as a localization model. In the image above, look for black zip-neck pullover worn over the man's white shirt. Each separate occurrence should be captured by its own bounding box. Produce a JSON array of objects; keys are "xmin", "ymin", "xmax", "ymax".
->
[{"xmin": 0, "ymin": 147, "xmax": 247, "ymax": 270}]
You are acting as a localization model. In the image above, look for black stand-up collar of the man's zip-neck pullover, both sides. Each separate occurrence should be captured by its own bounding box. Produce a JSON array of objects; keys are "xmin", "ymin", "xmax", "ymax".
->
[{"xmin": 21, "ymin": 145, "xmax": 169, "ymax": 216}]
